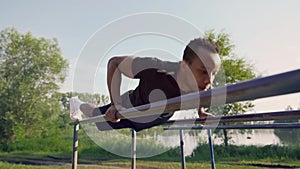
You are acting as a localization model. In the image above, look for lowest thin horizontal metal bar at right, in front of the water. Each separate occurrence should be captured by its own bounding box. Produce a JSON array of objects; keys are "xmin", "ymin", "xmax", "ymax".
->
[{"xmin": 164, "ymin": 123, "xmax": 300, "ymax": 130}]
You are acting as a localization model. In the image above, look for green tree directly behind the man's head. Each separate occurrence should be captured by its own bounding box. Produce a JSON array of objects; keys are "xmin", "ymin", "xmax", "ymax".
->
[{"xmin": 205, "ymin": 30, "xmax": 256, "ymax": 146}]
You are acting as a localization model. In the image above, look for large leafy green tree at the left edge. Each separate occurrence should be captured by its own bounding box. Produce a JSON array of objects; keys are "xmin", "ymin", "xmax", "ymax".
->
[{"xmin": 0, "ymin": 28, "xmax": 68, "ymax": 148}]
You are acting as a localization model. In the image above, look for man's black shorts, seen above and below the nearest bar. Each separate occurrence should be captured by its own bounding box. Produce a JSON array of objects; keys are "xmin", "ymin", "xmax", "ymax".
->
[{"xmin": 94, "ymin": 104, "xmax": 173, "ymax": 131}]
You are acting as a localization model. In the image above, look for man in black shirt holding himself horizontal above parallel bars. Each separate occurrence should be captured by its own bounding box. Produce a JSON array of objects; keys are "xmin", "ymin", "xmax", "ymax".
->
[{"xmin": 70, "ymin": 38, "xmax": 221, "ymax": 131}]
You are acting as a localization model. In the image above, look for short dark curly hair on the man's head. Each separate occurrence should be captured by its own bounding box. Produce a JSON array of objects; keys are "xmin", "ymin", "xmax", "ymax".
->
[{"xmin": 183, "ymin": 38, "xmax": 220, "ymax": 63}]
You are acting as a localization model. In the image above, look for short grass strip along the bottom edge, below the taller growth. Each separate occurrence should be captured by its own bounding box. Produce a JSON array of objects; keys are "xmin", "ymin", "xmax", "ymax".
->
[{"xmin": 0, "ymin": 154, "xmax": 300, "ymax": 169}]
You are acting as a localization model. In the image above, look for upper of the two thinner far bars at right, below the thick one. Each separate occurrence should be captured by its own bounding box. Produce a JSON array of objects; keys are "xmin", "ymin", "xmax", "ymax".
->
[{"xmin": 164, "ymin": 110, "xmax": 300, "ymax": 125}]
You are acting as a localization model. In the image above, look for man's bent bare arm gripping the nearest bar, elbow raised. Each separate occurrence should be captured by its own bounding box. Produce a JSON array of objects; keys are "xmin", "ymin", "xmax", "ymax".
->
[{"xmin": 105, "ymin": 56, "xmax": 134, "ymax": 122}]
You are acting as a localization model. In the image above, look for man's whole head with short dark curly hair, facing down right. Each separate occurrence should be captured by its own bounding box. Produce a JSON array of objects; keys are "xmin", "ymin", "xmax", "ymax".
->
[{"xmin": 182, "ymin": 38, "xmax": 221, "ymax": 91}]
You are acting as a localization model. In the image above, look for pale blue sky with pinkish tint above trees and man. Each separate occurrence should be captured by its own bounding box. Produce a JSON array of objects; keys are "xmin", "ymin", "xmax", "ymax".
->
[{"xmin": 0, "ymin": 0, "xmax": 300, "ymax": 112}]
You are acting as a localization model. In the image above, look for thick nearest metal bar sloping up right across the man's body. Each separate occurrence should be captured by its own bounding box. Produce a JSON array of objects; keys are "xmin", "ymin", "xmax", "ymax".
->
[{"xmin": 74, "ymin": 69, "xmax": 300, "ymax": 123}]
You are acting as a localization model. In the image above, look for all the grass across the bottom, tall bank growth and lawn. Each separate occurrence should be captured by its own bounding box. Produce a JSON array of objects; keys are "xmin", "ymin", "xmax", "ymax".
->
[{"xmin": 0, "ymin": 139, "xmax": 300, "ymax": 169}]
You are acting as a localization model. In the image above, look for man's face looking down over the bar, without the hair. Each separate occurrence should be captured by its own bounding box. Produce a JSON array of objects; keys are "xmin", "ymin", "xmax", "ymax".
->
[{"xmin": 186, "ymin": 48, "xmax": 221, "ymax": 92}]
